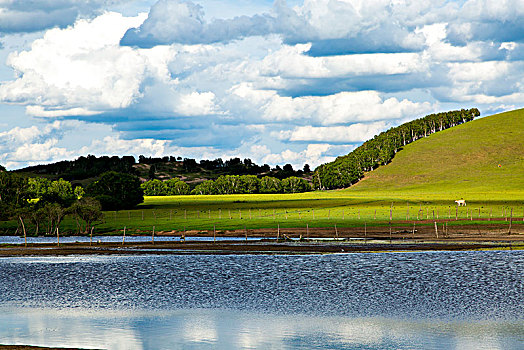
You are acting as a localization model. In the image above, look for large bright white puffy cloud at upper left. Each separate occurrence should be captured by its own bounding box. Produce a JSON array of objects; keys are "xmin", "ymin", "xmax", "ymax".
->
[{"xmin": 0, "ymin": 13, "xmax": 148, "ymax": 114}]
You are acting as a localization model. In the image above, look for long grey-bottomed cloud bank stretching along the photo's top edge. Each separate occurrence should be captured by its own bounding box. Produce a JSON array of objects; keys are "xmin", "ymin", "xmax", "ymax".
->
[{"xmin": 121, "ymin": 0, "xmax": 431, "ymax": 54}]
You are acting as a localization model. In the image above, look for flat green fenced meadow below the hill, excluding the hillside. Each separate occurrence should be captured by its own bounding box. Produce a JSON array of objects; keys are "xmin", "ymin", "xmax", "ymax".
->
[{"xmin": 2, "ymin": 190, "xmax": 524, "ymax": 234}]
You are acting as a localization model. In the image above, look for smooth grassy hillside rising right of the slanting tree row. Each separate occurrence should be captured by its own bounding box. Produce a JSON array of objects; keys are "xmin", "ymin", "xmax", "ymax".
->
[{"xmin": 349, "ymin": 109, "xmax": 524, "ymax": 200}]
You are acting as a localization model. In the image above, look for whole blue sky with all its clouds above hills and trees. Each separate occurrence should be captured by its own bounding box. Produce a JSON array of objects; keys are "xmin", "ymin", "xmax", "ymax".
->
[{"xmin": 0, "ymin": 0, "xmax": 524, "ymax": 169}]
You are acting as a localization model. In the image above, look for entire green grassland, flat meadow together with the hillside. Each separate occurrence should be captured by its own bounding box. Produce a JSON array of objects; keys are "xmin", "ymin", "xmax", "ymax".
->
[{"xmin": 0, "ymin": 110, "xmax": 524, "ymax": 234}]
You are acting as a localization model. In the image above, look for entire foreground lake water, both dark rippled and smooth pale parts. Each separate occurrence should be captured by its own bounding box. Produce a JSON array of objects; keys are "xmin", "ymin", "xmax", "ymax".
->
[{"xmin": 0, "ymin": 251, "xmax": 524, "ymax": 349}]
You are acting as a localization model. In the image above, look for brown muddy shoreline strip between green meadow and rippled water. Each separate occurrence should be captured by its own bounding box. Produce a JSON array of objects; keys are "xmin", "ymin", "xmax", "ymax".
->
[{"xmin": 0, "ymin": 237, "xmax": 524, "ymax": 257}]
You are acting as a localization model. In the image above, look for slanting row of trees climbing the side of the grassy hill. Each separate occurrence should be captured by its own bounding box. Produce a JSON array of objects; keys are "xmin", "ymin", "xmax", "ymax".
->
[{"xmin": 313, "ymin": 108, "xmax": 480, "ymax": 189}]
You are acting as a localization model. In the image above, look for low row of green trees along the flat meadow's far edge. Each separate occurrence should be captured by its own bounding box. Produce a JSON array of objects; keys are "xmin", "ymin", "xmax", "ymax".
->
[{"xmin": 142, "ymin": 175, "xmax": 312, "ymax": 196}]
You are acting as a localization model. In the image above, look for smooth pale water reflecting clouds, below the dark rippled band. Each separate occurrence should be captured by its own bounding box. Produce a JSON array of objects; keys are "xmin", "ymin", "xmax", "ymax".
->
[{"xmin": 0, "ymin": 308, "xmax": 524, "ymax": 350}]
